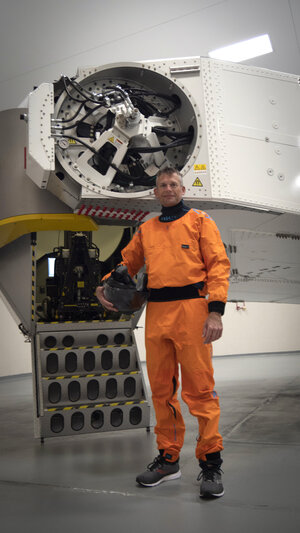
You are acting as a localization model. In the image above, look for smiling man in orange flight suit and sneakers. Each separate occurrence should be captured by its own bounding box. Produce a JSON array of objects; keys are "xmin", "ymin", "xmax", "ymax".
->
[{"xmin": 97, "ymin": 167, "xmax": 230, "ymax": 497}]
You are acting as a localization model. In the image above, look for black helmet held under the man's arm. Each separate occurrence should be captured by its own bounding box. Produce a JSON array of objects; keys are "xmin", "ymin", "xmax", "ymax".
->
[{"xmin": 104, "ymin": 265, "xmax": 148, "ymax": 314}]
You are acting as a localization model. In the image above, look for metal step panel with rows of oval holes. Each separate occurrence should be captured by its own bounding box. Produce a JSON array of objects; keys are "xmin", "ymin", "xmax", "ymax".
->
[{"xmin": 33, "ymin": 320, "xmax": 150, "ymax": 438}]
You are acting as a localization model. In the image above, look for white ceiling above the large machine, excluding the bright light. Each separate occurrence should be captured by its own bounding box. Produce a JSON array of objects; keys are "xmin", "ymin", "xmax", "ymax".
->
[{"xmin": 0, "ymin": 0, "xmax": 300, "ymax": 109}]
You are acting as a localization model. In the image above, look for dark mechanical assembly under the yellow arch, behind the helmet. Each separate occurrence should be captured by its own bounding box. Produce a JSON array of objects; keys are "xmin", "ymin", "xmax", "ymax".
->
[{"xmin": 37, "ymin": 228, "xmax": 134, "ymax": 322}]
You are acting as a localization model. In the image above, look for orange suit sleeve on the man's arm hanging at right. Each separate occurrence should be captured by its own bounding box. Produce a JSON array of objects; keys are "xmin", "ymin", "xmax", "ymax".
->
[{"xmin": 200, "ymin": 214, "xmax": 230, "ymax": 315}]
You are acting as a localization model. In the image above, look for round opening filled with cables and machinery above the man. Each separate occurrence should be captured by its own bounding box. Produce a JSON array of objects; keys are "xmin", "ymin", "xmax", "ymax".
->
[{"xmin": 52, "ymin": 67, "xmax": 197, "ymax": 194}]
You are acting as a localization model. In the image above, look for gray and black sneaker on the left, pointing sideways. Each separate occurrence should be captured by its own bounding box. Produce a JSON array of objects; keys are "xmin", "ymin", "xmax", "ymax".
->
[{"xmin": 136, "ymin": 455, "xmax": 181, "ymax": 487}]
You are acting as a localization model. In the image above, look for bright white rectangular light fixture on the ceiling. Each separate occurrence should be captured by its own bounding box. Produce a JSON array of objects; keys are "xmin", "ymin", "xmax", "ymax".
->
[{"xmin": 208, "ymin": 34, "xmax": 273, "ymax": 62}]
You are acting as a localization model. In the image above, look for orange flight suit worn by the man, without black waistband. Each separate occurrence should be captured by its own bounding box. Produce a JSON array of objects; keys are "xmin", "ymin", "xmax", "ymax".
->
[{"xmin": 122, "ymin": 209, "xmax": 230, "ymax": 461}]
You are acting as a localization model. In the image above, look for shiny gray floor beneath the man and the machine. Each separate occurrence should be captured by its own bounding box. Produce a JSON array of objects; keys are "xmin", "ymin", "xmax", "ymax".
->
[{"xmin": 0, "ymin": 352, "xmax": 300, "ymax": 533}]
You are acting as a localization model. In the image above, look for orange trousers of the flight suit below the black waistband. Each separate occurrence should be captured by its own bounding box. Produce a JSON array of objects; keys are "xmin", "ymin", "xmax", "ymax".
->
[{"xmin": 146, "ymin": 299, "xmax": 223, "ymax": 460}]
